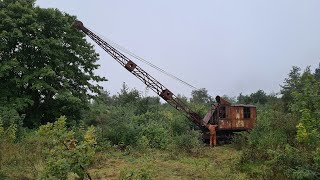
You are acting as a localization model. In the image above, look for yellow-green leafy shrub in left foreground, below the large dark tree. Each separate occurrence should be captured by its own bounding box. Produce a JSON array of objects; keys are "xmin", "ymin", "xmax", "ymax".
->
[{"xmin": 38, "ymin": 117, "xmax": 96, "ymax": 179}]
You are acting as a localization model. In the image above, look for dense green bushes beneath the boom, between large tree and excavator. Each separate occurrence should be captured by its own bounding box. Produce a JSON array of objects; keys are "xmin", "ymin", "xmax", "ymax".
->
[{"xmin": 84, "ymin": 84, "xmax": 205, "ymax": 152}]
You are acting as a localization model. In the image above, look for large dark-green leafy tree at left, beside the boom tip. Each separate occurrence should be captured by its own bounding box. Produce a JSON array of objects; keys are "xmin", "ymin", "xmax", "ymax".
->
[{"xmin": 0, "ymin": 0, "xmax": 105, "ymax": 127}]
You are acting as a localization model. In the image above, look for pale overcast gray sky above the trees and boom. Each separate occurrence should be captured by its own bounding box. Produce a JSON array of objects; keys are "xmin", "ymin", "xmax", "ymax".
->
[{"xmin": 37, "ymin": 0, "xmax": 320, "ymax": 96}]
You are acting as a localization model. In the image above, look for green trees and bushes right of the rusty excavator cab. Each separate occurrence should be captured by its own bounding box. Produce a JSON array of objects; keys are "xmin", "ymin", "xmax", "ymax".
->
[{"xmin": 234, "ymin": 67, "xmax": 320, "ymax": 179}]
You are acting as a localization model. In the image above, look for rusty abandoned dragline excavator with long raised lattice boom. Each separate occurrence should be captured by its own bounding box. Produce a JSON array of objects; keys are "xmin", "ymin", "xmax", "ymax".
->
[{"xmin": 74, "ymin": 20, "xmax": 256, "ymax": 146}]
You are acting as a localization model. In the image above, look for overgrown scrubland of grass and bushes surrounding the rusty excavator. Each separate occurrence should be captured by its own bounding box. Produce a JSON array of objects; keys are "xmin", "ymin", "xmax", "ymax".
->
[{"xmin": 0, "ymin": 65, "xmax": 320, "ymax": 179}]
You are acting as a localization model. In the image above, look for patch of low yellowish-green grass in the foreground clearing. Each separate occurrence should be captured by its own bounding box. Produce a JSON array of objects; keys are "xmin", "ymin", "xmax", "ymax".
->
[{"xmin": 89, "ymin": 146, "xmax": 248, "ymax": 179}]
